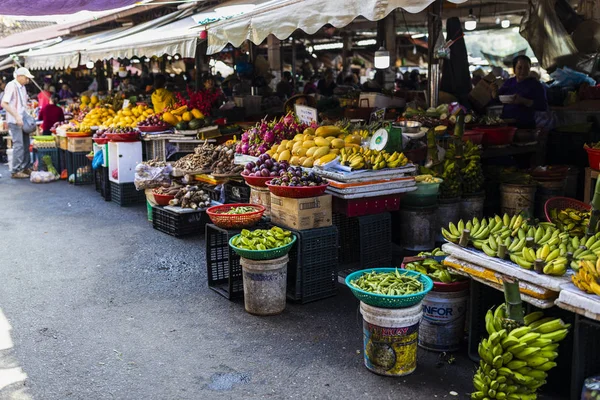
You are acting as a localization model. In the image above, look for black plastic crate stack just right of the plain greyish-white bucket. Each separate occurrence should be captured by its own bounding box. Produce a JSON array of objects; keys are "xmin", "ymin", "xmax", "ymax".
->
[{"xmin": 287, "ymin": 226, "xmax": 338, "ymax": 304}]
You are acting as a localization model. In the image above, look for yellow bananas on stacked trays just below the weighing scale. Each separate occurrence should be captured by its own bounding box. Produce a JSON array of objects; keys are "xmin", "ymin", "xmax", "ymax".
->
[{"xmin": 340, "ymin": 147, "xmax": 408, "ymax": 170}]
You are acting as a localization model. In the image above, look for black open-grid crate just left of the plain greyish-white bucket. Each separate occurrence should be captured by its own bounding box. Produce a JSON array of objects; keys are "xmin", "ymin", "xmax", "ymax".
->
[{"xmin": 204, "ymin": 224, "xmax": 244, "ymax": 300}]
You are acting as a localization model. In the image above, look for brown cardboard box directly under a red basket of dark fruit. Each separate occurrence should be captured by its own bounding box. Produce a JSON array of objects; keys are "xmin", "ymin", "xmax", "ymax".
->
[{"xmin": 271, "ymin": 193, "xmax": 332, "ymax": 230}]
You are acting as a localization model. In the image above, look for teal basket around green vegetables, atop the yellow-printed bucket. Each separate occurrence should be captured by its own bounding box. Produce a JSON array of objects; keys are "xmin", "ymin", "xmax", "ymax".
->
[{"xmin": 346, "ymin": 268, "xmax": 433, "ymax": 308}]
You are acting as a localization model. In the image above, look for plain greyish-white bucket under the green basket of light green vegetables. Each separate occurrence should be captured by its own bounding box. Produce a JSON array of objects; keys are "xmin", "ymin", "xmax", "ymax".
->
[{"xmin": 240, "ymin": 255, "xmax": 288, "ymax": 315}]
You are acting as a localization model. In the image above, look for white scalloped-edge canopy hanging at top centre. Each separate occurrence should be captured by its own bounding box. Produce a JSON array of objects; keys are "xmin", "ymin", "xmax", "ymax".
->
[{"xmin": 207, "ymin": 0, "xmax": 465, "ymax": 54}]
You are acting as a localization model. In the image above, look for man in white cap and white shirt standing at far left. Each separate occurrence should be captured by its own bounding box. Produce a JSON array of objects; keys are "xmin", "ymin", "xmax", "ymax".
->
[{"xmin": 2, "ymin": 67, "xmax": 33, "ymax": 179}]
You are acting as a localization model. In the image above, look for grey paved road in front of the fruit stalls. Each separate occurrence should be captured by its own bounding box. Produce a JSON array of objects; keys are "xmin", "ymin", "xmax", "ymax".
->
[{"xmin": 0, "ymin": 166, "xmax": 475, "ymax": 400}]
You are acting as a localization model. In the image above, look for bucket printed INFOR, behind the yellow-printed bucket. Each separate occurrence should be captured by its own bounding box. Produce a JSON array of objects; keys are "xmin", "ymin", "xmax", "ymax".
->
[{"xmin": 419, "ymin": 281, "xmax": 469, "ymax": 351}]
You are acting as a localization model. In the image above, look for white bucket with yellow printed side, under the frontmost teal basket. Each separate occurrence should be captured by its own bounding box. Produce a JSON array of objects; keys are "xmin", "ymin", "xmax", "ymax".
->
[{"xmin": 360, "ymin": 301, "xmax": 423, "ymax": 376}]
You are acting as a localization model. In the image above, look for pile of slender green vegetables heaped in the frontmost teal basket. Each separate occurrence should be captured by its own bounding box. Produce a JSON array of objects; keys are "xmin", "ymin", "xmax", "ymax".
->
[{"xmin": 350, "ymin": 269, "xmax": 423, "ymax": 296}]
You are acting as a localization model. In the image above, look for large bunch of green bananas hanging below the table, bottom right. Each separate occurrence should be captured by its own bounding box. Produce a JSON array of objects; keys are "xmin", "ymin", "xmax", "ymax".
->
[{"xmin": 471, "ymin": 304, "xmax": 570, "ymax": 400}]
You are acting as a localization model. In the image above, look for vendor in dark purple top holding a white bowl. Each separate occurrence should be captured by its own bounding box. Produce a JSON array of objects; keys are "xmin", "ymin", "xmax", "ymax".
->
[{"xmin": 492, "ymin": 56, "xmax": 548, "ymax": 129}]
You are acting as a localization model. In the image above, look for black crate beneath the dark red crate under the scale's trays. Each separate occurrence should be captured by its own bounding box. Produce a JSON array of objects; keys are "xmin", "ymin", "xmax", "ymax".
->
[{"xmin": 332, "ymin": 213, "xmax": 392, "ymax": 269}]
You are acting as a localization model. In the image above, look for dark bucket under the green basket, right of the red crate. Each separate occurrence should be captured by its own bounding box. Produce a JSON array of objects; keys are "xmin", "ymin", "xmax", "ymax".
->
[{"xmin": 400, "ymin": 206, "xmax": 438, "ymax": 251}]
